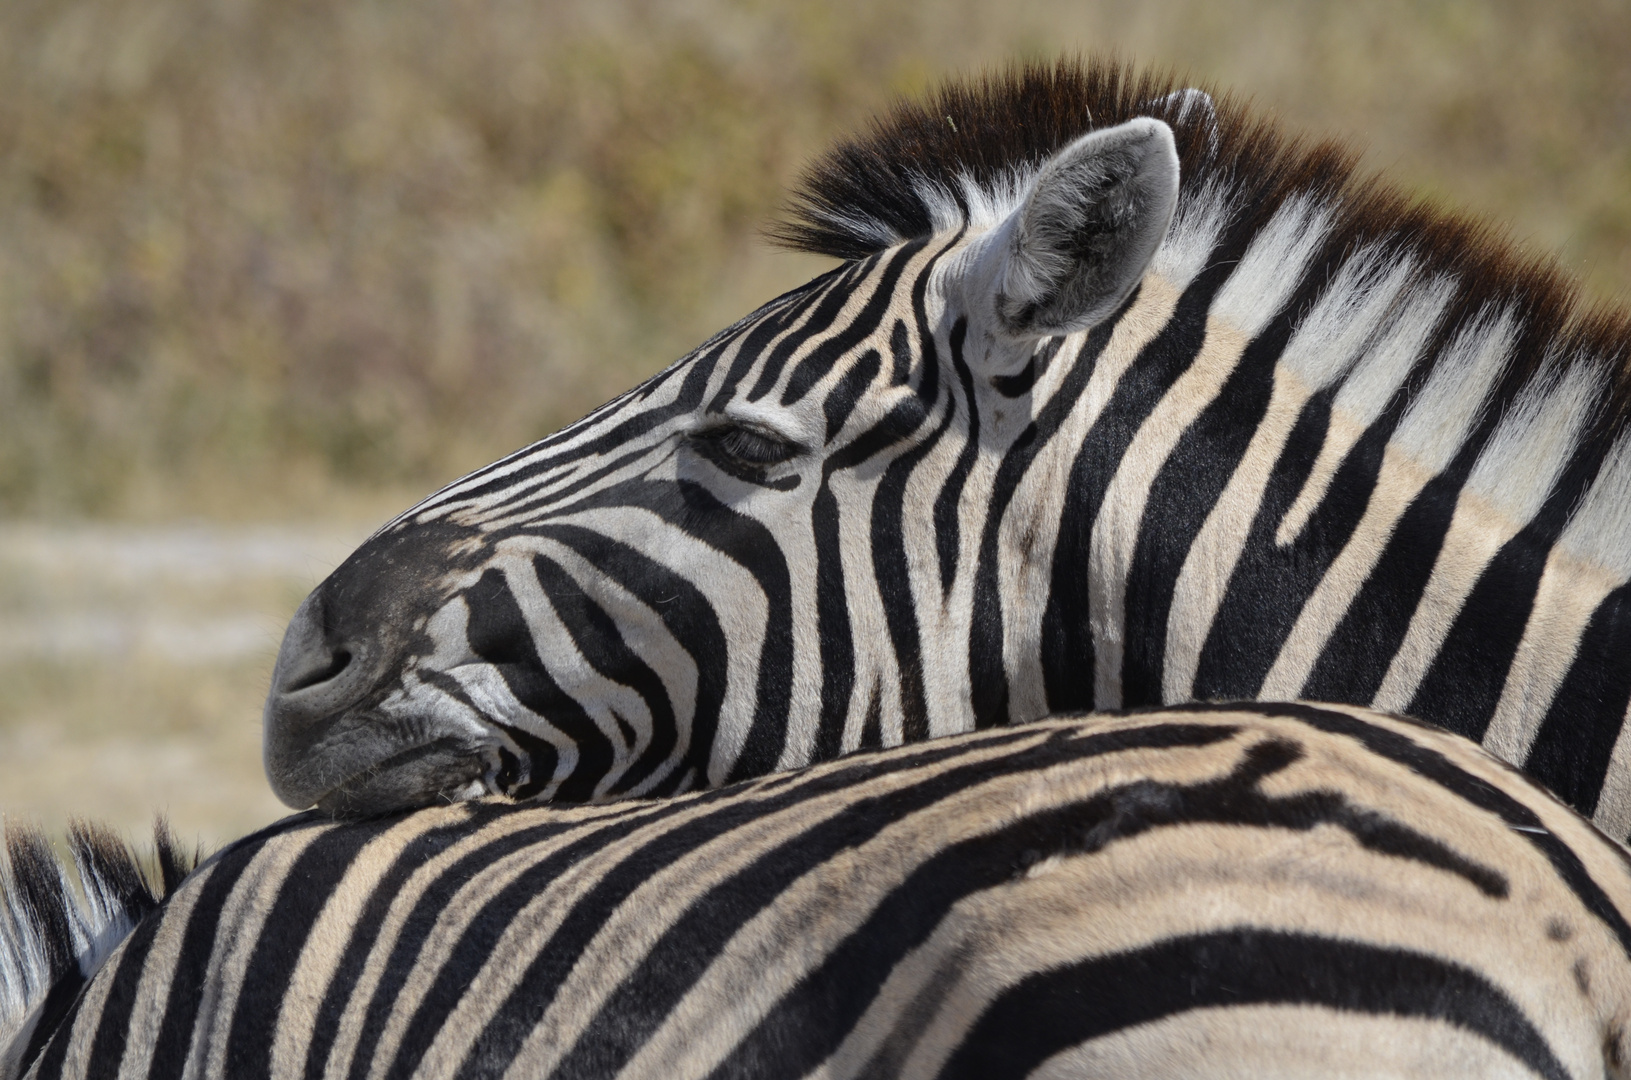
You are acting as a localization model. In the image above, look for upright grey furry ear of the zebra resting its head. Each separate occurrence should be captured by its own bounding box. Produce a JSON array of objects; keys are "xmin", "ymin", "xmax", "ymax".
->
[{"xmin": 990, "ymin": 117, "xmax": 1178, "ymax": 338}]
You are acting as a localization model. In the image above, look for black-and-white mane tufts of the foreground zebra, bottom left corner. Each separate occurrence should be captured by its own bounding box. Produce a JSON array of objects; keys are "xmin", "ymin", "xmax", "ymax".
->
[{"xmin": 0, "ymin": 819, "xmax": 199, "ymax": 1077}]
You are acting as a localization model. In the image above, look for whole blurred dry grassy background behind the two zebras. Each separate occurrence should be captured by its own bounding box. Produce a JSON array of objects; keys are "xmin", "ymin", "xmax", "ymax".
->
[{"xmin": 0, "ymin": 0, "xmax": 1631, "ymax": 840}]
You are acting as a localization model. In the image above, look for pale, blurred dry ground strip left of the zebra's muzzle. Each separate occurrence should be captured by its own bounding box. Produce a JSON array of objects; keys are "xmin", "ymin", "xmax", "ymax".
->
[{"xmin": 0, "ymin": 524, "xmax": 378, "ymax": 843}]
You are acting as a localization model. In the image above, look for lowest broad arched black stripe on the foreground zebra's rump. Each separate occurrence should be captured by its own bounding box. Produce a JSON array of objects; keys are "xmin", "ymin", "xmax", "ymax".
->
[{"xmin": 939, "ymin": 927, "xmax": 1572, "ymax": 1080}]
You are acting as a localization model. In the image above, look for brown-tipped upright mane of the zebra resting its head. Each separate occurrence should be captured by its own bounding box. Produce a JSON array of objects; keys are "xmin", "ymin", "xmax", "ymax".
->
[{"xmin": 768, "ymin": 59, "xmax": 1631, "ymax": 447}]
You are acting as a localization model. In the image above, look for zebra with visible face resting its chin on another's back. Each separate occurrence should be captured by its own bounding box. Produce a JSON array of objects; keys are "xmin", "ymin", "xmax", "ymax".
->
[{"xmin": 264, "ymin": 62, "xmax": 1631, "ymax": 837}]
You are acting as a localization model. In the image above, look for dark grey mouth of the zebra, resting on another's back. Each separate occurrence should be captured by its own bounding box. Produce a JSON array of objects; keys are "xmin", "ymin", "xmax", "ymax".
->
[{"xmin": 313, "ymin": 736, "xmax": 502, "ymax": 817}]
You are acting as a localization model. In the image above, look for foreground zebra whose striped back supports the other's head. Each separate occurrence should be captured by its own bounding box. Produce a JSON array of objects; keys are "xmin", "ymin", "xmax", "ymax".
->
[{"xmin": 9, "ymin": 703, "xmax": 1631, "ymax": 1080}]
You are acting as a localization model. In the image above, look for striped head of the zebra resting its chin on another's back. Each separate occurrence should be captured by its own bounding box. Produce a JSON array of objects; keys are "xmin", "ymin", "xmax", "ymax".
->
[{"xmin": 264, "ymin": 107, "xmax": 1191, "ymax": 812}]
